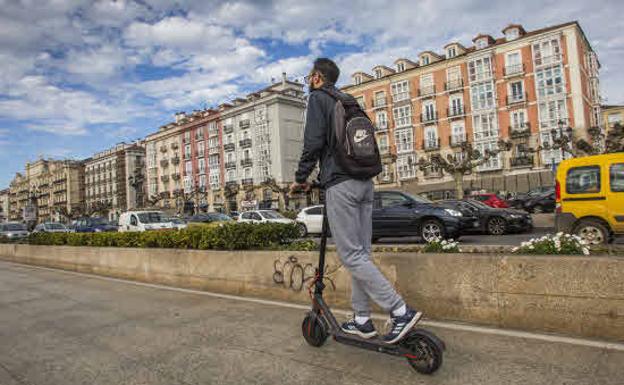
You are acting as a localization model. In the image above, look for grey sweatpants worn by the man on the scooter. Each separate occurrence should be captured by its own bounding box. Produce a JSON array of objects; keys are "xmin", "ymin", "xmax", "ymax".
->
[{"xmin": 325, "ymin": 179, "xmax": 404, "ymax": 317}]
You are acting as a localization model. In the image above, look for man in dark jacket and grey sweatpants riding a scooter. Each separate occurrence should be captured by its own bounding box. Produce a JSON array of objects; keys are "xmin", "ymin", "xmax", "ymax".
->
[{"xmin": 291, "ymin": 58, "xmax": 422, "ymax": 344}]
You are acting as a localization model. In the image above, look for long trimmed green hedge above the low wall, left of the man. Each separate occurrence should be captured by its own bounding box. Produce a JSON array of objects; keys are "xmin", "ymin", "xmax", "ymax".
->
[{"xmin": 0, "ymin": 223, "xmax": 316, "ymax": 250}]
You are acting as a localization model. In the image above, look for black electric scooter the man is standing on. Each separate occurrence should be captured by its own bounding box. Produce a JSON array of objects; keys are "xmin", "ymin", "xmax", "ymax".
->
[{"xmin": 301, "ymin": 185, "xmax": 445, "ymax": 374}]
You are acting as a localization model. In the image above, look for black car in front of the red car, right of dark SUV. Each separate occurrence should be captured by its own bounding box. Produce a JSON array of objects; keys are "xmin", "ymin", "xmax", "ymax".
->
[{"xmin": 443, "ymin": 199, "xmax": 533, "ymax": 235}]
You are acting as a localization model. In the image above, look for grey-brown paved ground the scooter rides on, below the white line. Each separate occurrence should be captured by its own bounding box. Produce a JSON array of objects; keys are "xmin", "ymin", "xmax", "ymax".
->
[{"xmin": 0, "ymin": 262, "xmax": 624, "ymax": 385}]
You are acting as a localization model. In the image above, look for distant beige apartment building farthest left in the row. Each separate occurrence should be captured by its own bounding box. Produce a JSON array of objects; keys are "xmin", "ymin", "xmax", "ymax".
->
[{"xmin": 9, "ymin": 159, "xmax": 84, "ymax": 222}]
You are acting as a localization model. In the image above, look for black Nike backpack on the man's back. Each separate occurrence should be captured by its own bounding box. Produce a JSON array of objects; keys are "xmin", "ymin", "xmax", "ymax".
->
[{"xmin": 321, "ymin": 87, "xmax": 382, "ymax": 179}]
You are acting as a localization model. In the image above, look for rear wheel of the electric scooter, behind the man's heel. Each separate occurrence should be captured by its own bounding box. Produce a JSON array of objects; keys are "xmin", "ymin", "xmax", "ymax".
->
[{"xmin": 401, "ymin": 329, "xmax": 444, "ymax": 374}]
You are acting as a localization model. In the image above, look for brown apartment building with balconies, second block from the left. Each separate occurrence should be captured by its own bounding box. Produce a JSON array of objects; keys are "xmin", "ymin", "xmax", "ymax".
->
[{"xmin": 84, "ymin": 143, "xmax": 145, "ymax": 220}]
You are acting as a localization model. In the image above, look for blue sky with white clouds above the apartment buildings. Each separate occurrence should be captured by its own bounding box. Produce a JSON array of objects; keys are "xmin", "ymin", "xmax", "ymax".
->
[{"xmin": 0, "ymin": 0, "xmax": 624, "ymax": 188}]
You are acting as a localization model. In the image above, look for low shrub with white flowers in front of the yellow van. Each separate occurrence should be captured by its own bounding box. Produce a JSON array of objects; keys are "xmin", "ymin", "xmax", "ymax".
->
[{"xmin": 512, "ymin": 232, "xmax": 590, "ymax": 255}]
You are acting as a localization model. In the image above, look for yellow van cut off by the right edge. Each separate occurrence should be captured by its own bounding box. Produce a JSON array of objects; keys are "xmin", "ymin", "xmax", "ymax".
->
[{"xmin": 555, "ymin": 152, "xmax": 624, "ymax": 245}]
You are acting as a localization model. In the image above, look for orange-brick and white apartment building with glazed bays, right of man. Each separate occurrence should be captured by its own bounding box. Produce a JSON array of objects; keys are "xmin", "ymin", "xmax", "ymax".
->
[{"xmin": 344, "ymin": 22, "xmax": 601, "ymax": 192}]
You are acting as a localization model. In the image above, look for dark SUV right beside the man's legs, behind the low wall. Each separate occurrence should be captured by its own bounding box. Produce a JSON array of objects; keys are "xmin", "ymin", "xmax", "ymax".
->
[{"xmin": 373, "ymin": 191, "xmax": 462, "ymax": 242}]
